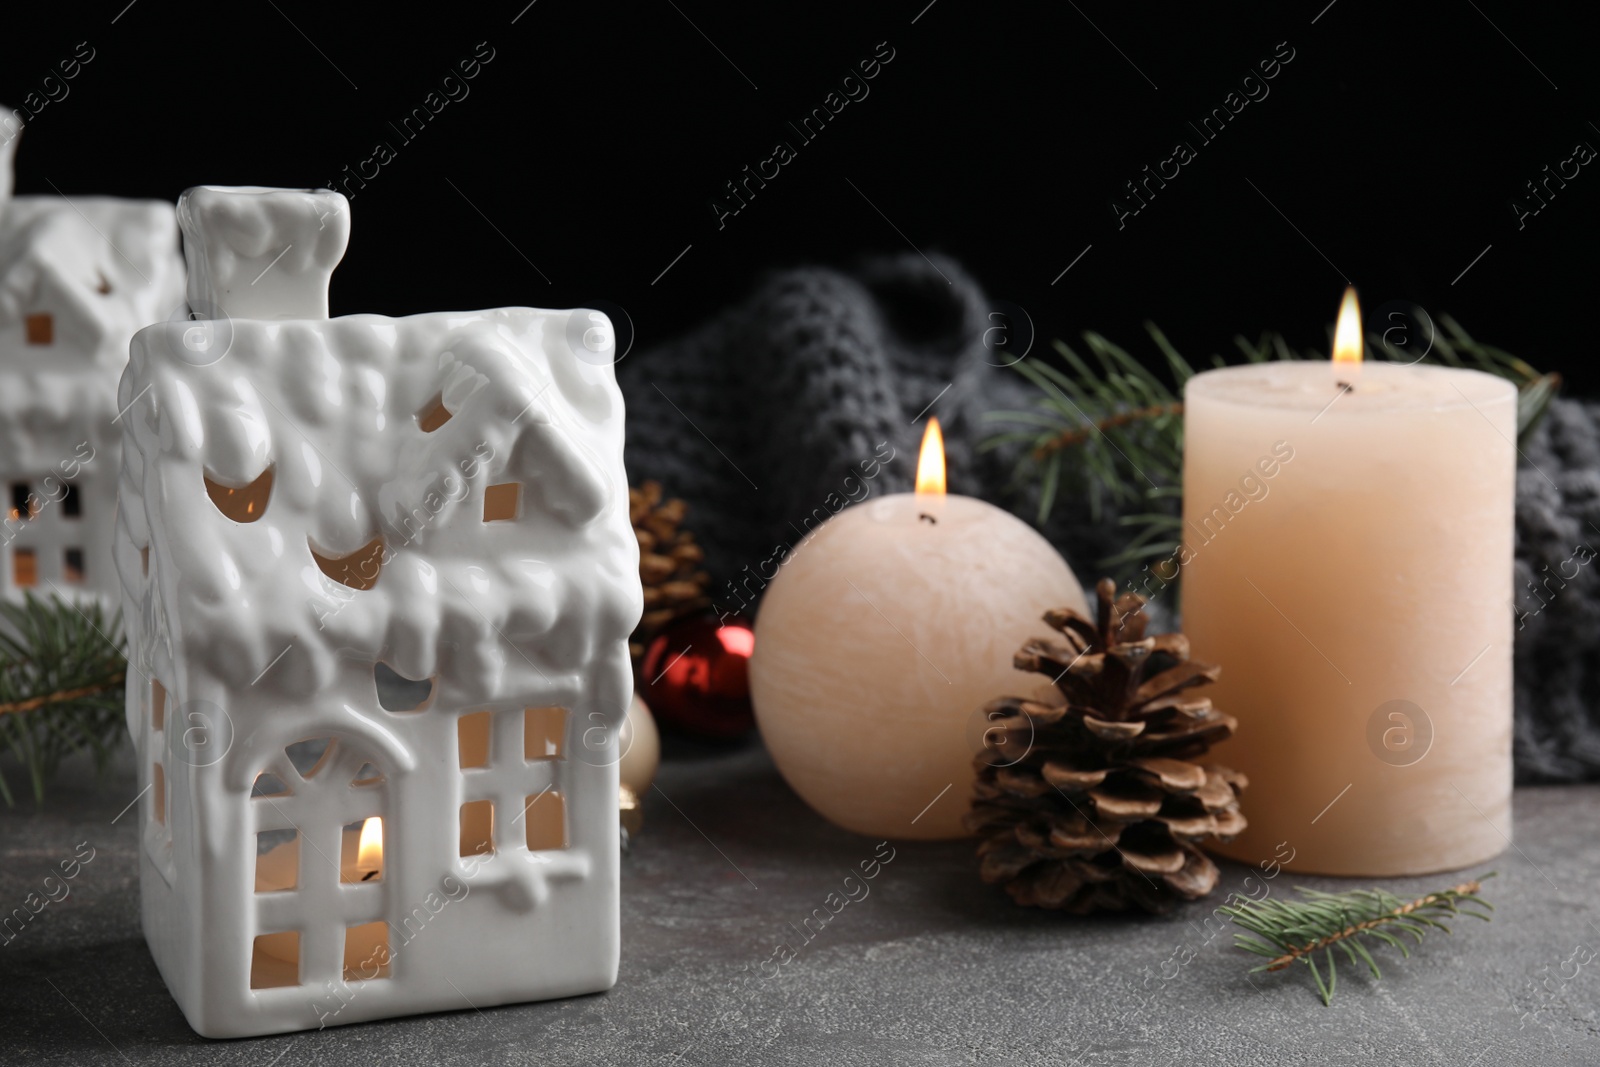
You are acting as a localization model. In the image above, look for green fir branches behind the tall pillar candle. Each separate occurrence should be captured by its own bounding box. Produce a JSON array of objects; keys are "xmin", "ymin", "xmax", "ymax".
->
[{"xmin": 982, "ymin": 315, "xmax": 1562, "ymax": 585}]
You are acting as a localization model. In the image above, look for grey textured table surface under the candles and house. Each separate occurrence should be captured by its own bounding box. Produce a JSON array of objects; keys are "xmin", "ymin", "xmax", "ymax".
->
[{"xmin": 0, "ymin": 747, "xmax": 1600, "ymax": 1067}]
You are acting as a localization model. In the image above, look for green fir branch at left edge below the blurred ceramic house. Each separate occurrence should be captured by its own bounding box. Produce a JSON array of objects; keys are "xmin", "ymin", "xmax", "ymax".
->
[{"xmin": 0, "ymin": 593, "xmax": 128, "ymax": 806}]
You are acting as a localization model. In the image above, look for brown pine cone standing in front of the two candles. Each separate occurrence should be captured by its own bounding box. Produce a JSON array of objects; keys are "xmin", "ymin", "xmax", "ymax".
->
[{"xmin": 966, "ymin": 577, "xmax": 1248, "ymax": 913}]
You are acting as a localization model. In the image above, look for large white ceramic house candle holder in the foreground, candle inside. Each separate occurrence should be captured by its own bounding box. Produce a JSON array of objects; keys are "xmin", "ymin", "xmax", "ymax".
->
[{"xmin": 115, "ymin": 187, "xmax": 642, "ymax": 1037}]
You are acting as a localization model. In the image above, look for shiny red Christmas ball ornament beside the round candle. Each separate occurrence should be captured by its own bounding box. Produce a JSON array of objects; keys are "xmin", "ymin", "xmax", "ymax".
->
[{"xmin": 640, "ymin": 617, "xmax": 755, "ymax": 741}]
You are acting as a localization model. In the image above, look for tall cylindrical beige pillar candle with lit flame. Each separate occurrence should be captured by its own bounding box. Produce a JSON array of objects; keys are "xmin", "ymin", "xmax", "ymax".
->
[{"xmin": 1179, "ymin": 293, "xmax": 1517, "ymax": 875}]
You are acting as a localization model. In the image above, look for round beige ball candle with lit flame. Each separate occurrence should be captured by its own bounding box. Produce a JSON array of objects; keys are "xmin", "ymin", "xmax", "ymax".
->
[{"xmin": 750, "ymin": 421, "xmax": 1088, "ymax": 838}]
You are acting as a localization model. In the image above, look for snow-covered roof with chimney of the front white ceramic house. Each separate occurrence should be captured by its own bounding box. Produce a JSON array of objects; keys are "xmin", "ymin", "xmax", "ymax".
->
[{"xmin": 117, "ymin": 190, "xmax": 642, "ymax": 702}]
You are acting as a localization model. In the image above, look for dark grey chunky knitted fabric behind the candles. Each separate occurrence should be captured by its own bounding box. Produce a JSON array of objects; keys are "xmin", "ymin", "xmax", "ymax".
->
[{"xmin": 618, "ymin": 254, "xmax": 1600, "ymax": 782}]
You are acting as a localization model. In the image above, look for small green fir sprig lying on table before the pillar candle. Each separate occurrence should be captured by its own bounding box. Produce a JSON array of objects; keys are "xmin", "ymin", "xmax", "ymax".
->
[{"xmin": 1218, "ymin": 872, "xmax": 1494, "ymax": 1005}]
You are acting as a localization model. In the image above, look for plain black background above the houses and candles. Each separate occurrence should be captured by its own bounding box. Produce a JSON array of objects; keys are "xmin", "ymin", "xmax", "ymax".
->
[{"xmin": 0, "ymin": 0, "xmax": 1600, "ymax": 394}]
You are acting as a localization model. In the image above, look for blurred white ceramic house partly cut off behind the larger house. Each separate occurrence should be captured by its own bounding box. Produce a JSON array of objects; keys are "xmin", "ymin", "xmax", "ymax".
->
[{"xmin": 0, "ymin": 107, "xmax": 184, "ymax": 606}]
